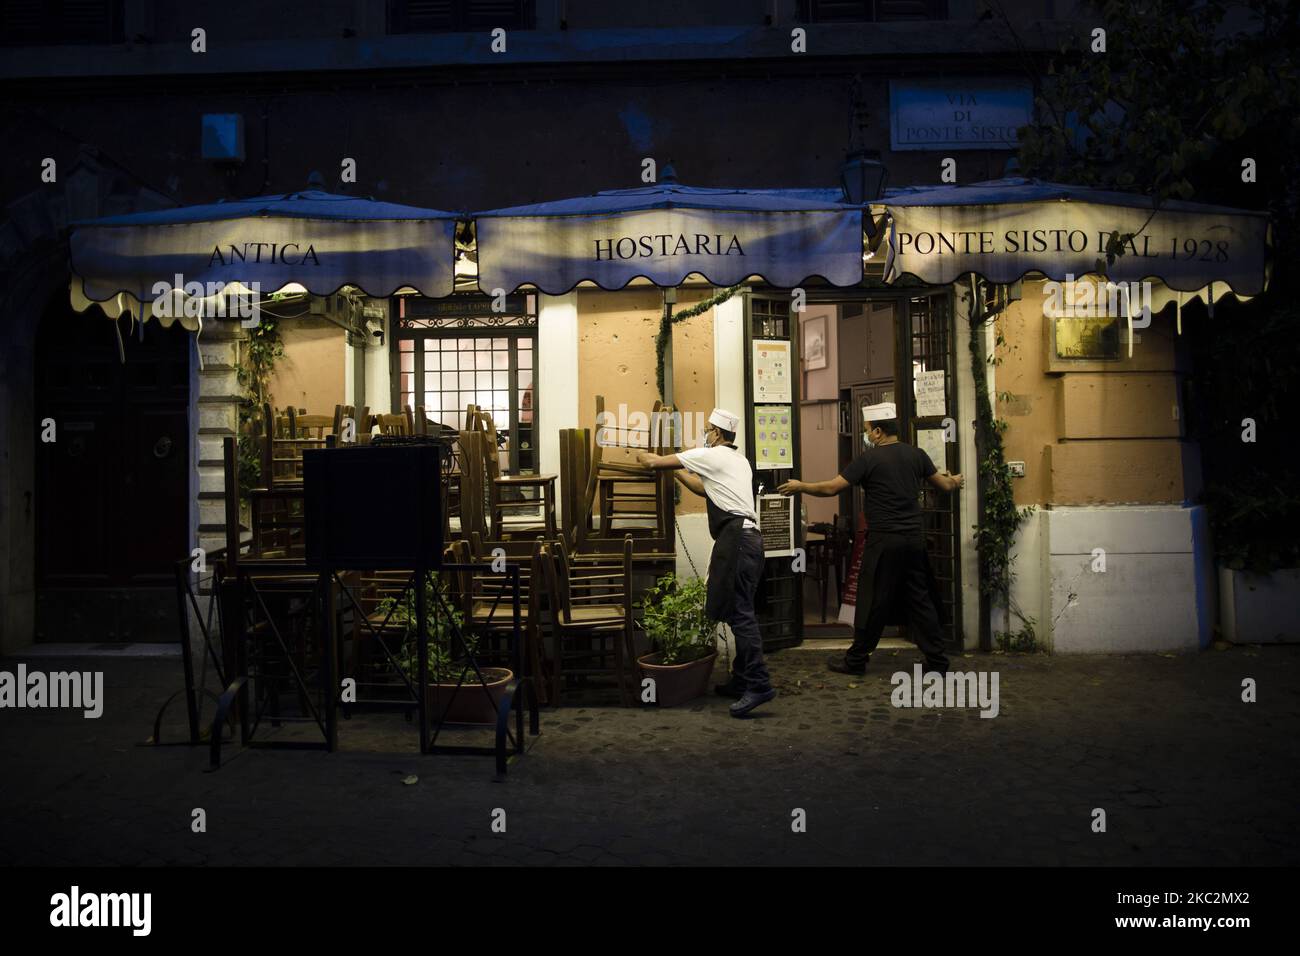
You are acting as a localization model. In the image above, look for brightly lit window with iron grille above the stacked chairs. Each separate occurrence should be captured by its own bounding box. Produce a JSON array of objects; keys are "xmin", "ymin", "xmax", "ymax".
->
[{"xmin": 393, "ymin": 295, "xmax": 537, "ymax": 472}]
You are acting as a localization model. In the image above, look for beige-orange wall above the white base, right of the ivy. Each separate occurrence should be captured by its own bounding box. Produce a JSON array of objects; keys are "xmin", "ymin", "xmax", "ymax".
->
[{"xmin": 995, "ymin": 282, "xmax": 1197, "ymax": 505}]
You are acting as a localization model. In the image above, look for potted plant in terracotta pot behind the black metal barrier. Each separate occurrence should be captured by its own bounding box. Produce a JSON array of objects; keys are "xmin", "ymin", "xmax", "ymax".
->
[{"xmin": 378, "ymin": 574, "xmax": 515, "ymax": 723}]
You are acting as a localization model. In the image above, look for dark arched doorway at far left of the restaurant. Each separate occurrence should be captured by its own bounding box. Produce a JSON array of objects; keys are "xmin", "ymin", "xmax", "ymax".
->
[{"xmin": 35, "ymin": 304, "xmax": 192, "ymax": 641}]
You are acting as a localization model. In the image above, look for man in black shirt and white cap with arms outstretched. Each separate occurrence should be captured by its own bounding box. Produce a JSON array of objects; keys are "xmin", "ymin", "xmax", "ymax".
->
[{"xmin": 777, "ymin": 402, "xmax": 963, "ymax": 674}]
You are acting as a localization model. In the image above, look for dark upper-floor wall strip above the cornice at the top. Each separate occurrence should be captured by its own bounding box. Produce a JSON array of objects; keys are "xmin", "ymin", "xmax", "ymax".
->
[{"xmin": 0, "ymin": 0, "xmax": 1082, "ymax": 79}]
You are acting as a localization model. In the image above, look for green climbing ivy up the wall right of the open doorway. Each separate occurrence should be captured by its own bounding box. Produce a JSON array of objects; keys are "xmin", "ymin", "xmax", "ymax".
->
[{"xmin": 970, "ymin": 287, "xmax": 1035, "ymax": 649}]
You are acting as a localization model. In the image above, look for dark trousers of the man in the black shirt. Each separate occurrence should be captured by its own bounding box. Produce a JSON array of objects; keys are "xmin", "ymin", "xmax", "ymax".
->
[{"xmin": 844, "ymin": 533, "xmax": 948, "ymax": 672}]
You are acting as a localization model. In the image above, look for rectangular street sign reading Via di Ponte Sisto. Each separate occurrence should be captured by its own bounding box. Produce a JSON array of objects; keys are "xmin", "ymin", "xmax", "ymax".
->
[{"xmin": 889, "ymin": 77, "xmax": 1034, "ymax": 150}]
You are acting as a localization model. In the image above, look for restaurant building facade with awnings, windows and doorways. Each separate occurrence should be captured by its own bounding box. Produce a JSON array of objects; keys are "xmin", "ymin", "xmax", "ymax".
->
[{"xmin": 0, "ymin": 1, "xmax": 1266, "ymax": 653}]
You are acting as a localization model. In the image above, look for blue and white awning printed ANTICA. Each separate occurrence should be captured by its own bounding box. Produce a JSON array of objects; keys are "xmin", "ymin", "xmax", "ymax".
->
[{"xmin": 72, "ymin": 190, "xmax": 458, "ymax": 328}]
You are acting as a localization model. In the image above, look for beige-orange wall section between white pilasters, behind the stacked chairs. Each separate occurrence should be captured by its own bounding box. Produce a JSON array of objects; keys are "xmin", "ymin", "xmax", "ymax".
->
[{"xmin": 577, "ymin": 289, "xmax": 714, "ymax": 514}]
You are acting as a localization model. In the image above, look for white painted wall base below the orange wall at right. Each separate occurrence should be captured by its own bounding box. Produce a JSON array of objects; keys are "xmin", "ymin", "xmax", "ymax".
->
[{"xmin": 1039, "ymin": 506, "xmax": 1213, "ymax": 654}]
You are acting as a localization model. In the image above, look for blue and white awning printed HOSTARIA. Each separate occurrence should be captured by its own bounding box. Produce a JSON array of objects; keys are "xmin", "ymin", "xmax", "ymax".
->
[{"xmin": 472, "ymin": 181, "xmax": 862, "ymax": 295}]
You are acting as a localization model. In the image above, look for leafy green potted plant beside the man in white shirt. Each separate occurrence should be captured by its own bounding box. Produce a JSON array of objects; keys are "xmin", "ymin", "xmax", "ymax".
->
[{"xmin": 637, "ymin": 574, "xmax": 718, "ymax": 708}]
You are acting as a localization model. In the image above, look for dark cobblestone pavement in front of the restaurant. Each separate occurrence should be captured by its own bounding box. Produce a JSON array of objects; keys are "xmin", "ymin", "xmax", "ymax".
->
[{"xmin": 0, "ymin": 648, "xmax": 1300, "ymax": 865}]
